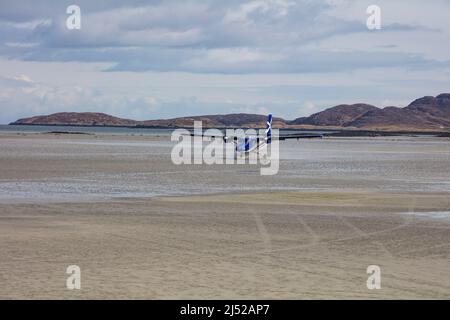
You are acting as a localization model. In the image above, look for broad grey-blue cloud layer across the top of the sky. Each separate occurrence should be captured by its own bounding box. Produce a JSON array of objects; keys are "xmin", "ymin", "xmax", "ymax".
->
[{"xmin": 0, "ymin": 0, "xmax": 450, "ymax": 73}]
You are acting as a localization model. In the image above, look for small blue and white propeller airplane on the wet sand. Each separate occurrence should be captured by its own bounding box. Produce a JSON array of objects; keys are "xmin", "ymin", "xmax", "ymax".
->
[{"xmin": 191, "ymin": 114, "xmax": 323, "ymax": 154}]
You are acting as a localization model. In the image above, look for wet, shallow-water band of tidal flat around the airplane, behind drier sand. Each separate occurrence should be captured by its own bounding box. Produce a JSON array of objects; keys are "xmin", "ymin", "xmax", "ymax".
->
[{"xmin": 0, "ymin": 132, "xmax": 450, "ymax": 199}]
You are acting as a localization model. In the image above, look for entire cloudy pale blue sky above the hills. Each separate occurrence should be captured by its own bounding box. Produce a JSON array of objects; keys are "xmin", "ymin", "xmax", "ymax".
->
[{"xmin": 0, "ymin": 0, "xmax": 450, "ymax": 123}]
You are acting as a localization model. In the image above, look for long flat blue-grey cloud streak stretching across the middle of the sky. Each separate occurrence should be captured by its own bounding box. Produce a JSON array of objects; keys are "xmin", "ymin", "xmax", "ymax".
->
[{"xmin": 22, "ymin": 48, "xmax": 444, "ymax": 74}]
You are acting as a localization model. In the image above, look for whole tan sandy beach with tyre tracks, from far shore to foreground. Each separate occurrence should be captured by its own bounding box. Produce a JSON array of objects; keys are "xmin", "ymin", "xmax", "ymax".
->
[{"xmin": 0, "ymin": 134, "xmax": 450, "ymax": 299}]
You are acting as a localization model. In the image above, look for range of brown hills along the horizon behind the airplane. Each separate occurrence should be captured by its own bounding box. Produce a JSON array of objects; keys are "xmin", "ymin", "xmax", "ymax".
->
[{"xmin": 11, "ymin": 93, "xmax": 450, "ymax": 131}]
